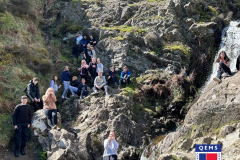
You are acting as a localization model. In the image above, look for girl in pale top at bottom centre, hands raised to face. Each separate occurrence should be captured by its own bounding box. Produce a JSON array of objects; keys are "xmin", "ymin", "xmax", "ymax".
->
[{"xmin": 103, "ymin": 131, "xmax": 119, "ymax": 160}]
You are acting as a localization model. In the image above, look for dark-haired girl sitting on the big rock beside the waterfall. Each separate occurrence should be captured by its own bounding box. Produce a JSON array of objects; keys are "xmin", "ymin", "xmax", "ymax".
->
[{"xmin": 213, "ymin": 51, "xmax": 232, "ymax": 83}]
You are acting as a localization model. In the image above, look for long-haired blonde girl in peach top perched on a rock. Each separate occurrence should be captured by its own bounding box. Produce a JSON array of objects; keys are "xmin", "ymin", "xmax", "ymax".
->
[{"xmin": 42, "ymin": 88, "xmax": 60, "ymax": 130}]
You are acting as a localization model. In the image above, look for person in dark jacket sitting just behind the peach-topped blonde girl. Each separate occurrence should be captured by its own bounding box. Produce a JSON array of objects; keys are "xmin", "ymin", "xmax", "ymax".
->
[{"xmin": 25, "ymin": 77, "xmax": 43, "ymax": 112}]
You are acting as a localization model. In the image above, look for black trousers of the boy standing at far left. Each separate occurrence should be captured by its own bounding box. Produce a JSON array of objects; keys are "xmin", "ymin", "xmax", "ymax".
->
[{"xmin": 14, "ymin": 123, "xmax": 29, "ymax": 150}]
